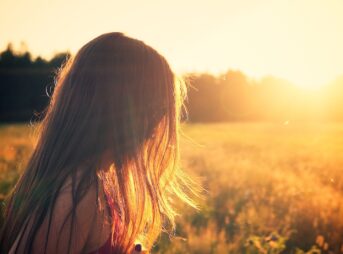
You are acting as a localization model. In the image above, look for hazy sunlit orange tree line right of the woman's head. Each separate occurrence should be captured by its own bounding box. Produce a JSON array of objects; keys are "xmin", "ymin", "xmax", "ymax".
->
[{"xmin": 186, "ymin": 70, "xmax": 343, "ymax": 123}]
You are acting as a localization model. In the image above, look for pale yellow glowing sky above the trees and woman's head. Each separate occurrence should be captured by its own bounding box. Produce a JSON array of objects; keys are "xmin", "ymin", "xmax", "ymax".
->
[{"xmin": 0, "ymin": 0, "xmax": 343, "ymax": 88}]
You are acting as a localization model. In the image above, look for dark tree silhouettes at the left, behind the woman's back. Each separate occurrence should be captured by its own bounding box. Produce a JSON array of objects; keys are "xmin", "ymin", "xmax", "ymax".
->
[{"xmin": 0, "ymin": 44, "xmax": 70, "ymax": 122}]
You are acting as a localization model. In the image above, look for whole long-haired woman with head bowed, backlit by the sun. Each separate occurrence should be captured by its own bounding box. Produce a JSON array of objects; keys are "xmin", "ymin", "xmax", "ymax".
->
[{"xmin": 0, "ymin": 33, "xmax": 198, "ymax": 253}]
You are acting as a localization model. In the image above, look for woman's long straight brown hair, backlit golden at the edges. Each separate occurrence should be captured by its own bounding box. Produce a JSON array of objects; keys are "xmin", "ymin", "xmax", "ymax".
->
[{"xmin": 4, "ymin": 33, "xmax": 196, "ymax": 252}]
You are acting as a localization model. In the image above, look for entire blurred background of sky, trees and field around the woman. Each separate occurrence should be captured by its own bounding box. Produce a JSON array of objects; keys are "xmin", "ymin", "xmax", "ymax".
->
[{"xmin": 0, "ymin": 0, "xmax": 343, "ymax": 253}]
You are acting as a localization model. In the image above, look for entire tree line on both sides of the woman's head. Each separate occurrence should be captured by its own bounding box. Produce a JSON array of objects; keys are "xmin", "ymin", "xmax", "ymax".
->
[{"xmin": 0, "ymin": 44, "xmax": 343, "ymax": 122}]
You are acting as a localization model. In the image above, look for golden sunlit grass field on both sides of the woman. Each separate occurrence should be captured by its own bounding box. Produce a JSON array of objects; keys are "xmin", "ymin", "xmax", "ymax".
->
[{"xmin": 0, "ymin": 122, "xmax": 343, "ymax": 253}]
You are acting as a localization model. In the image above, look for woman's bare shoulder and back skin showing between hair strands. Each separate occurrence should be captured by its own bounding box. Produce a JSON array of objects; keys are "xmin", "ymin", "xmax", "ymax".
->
[{"xmin": 10, "ymin": 172, "xmax": 111, "ymax": 254}]
